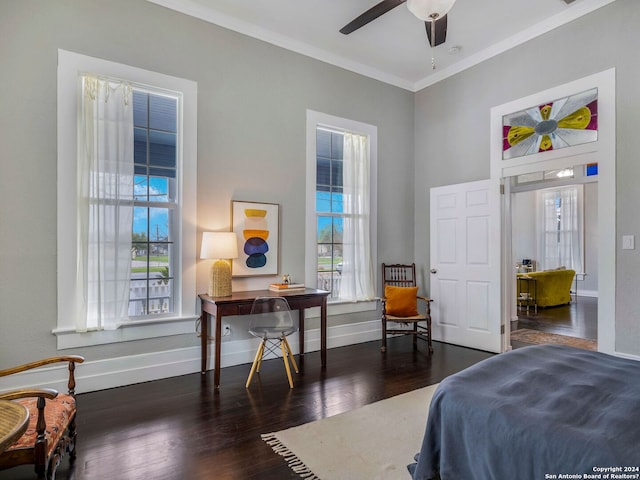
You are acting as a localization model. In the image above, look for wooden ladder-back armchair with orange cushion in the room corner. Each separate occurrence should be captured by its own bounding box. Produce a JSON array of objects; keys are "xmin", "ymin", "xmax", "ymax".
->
[{"xmin": 380, "ymin": 263, "xmax": 433, "ymax": 354}]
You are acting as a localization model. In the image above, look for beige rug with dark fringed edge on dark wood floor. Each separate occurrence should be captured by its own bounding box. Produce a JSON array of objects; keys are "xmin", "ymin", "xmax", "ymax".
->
[{"xmin": 262, "ymin": 384, "xmax": 438, "ymax": 480}]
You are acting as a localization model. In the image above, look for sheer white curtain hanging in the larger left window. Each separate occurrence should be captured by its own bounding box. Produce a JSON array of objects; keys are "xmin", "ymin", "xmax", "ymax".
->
[{"xmin": 76, "ymin": 75, "xmax": 134, "ymax": 332}]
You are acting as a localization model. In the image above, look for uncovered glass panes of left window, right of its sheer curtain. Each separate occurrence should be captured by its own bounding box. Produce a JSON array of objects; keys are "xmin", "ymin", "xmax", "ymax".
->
[{"xmin": 129, "ymin": 89, "xmax": 179, "ymax": 317}]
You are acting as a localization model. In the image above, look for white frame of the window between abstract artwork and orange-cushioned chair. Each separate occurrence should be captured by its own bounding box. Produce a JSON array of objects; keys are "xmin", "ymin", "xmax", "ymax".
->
[{"xmin": 305, "ymin": 110, "xmax": 378, "ymax": 315}]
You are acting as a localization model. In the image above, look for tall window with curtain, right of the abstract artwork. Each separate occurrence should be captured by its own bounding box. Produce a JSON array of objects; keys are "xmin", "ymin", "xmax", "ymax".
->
[{"xmin": 306, "ymin": 112, "xmax": 377, "ymax": 302}]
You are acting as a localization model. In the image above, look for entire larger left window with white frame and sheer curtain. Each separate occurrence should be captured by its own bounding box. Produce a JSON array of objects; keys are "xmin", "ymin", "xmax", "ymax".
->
[{"xmin": 54, "ymin": 50, "xmax": 197, "ymax": 348}]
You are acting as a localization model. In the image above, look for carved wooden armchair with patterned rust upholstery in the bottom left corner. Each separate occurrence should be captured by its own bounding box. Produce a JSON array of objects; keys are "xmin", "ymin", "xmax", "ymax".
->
[{"xmin": 0, "ymin": 355, "xmax": 84, "ymax": 479}]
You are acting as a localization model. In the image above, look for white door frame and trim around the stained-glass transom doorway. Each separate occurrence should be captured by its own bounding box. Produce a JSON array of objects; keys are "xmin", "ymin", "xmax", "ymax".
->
[{"xmin": 490, "ymin": 68, "xmax": 616, "ymax": 354}]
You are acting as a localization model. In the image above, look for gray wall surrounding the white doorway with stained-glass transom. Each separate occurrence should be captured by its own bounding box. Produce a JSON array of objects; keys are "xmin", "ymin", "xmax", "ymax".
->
[{"xmin": 415, "ymin": 0, "xmax": 640, "ymax": 355}]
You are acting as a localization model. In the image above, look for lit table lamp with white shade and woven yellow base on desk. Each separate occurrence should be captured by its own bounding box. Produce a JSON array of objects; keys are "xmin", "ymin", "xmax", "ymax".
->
[{"xmin": 200, "ymin": 232, "xmax": 238, "ymax": 297}]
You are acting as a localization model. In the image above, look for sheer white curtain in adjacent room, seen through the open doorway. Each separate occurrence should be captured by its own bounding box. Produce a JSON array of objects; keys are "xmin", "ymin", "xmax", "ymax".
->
[{"xmin": 539, "ymin": 185, "xmax": 583, "ymax": 273}]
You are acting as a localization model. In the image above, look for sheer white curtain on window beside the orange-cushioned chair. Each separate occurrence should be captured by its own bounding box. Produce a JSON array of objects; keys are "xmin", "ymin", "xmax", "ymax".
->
[{"xmin": 340, "ymin": 133, "xmax": 375, "ymax": 301}]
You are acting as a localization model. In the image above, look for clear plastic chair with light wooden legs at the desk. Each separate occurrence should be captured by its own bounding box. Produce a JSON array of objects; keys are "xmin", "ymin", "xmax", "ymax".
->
[{"xmin": 246, "ymin": 297, "xmax": 299, "ymax": 388}]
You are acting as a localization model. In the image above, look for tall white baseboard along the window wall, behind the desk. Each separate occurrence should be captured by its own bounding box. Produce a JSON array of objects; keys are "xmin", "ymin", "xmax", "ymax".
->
[{"xmin": 0, "ymin": 320, "xmax": 382, "ymax": 393}]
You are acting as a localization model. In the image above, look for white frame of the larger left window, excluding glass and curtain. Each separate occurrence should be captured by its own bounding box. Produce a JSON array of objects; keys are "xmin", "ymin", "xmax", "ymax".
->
[{"xmin": 53, "ymin": 49, "xmax": 198, "ymax": 350}]
